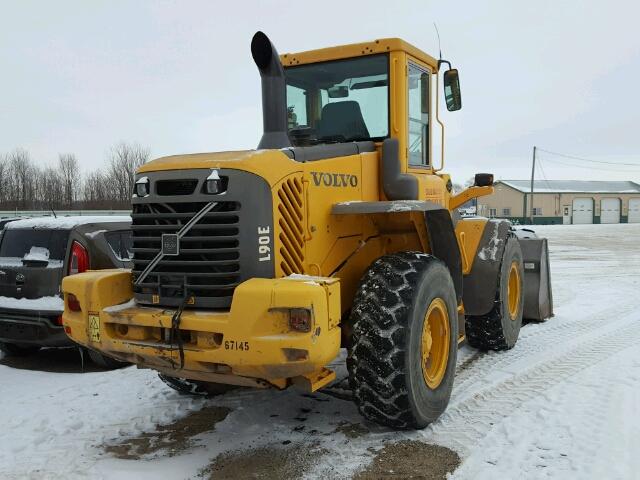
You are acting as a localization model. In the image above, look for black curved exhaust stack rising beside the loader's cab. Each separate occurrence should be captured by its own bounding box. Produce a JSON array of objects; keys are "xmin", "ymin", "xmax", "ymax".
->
[{"xmin": 251, "ymin": 32, "xmax": 291, "ymax": 149}]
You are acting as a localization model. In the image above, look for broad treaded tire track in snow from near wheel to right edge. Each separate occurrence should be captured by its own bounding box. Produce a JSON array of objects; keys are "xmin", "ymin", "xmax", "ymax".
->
[{"xmin": 425, "ymin": 313, "xmax": 640, "ymax": 454}]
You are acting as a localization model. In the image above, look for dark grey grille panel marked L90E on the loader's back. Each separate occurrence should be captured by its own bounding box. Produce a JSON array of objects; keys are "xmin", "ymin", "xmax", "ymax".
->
[{"xmin": 131, "ymin": 168, "xmax": 275, "ymax": 310}]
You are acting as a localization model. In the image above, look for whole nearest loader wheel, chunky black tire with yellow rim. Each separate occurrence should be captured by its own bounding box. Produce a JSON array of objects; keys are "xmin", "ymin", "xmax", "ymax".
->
[{"xmin": 347, "ymin": 252, "xmax": 458, "ymax": 428}]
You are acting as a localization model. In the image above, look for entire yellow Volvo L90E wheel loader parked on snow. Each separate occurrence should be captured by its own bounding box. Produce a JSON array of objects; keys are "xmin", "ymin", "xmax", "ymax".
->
[{"xmin": 62, "ymin": 32, "xmax": 552, "ymax": 428}]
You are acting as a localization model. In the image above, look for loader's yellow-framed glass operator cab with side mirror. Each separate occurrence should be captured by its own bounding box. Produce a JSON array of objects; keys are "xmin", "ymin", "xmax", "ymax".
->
[{"xmin": 281, "ymin": 38, "xmax": 462, "ymax": 168}]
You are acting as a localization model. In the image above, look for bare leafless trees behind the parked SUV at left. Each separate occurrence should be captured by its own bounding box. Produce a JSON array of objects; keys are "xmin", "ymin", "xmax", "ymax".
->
[{"xmin": 0, "ymin": 142, "xmax": 150, "ymax": 210}]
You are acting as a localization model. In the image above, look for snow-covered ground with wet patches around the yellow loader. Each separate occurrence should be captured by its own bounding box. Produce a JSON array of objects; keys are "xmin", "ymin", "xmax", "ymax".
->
[{"xmin": 0, "ymin": 225, "xmax": 640, "ymax": 480}]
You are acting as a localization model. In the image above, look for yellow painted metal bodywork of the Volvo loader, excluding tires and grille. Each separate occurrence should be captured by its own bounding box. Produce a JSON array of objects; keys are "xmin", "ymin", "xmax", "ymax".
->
[{"xmin": 62, "ymin": 39, "xmax": 491, "ymax": 390}]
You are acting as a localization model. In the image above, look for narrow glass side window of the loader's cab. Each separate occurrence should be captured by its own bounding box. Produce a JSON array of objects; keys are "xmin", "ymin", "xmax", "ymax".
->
[{"xmin": 408, "ymin": 64, "xmax": 429, "ymax": 166}]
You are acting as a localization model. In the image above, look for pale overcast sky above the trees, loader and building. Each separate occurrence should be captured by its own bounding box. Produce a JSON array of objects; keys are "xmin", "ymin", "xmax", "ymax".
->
[{"xmin": 0, "ymin": 0, "xmax": 640, "ymax": 182}]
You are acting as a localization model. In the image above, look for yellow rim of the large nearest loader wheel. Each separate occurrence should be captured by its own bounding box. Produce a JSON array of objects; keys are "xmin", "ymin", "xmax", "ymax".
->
[{"xmin": 422, "ymin": 298, "xmax": 451, "ymax": 390}]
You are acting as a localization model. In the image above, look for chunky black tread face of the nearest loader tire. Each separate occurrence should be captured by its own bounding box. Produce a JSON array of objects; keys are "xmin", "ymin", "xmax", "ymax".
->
[{"xmin": 347, "ymin": 252, "xmax": 440, "ymax": 428}]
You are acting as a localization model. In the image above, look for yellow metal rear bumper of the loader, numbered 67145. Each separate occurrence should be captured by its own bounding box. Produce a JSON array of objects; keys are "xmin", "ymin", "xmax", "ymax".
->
[{"xmin": 62, "ymin": 270, "xmax": 341, "ymax": 390}]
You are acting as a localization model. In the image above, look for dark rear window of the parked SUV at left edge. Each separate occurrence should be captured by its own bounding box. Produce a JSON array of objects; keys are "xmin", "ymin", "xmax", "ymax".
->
[{"xmin": 0, "ymin": 229, "xmax": 69, "ymax": 260}]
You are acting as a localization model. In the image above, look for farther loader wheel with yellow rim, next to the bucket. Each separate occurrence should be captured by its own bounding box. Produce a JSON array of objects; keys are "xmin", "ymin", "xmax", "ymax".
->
[{"xmin": 465, "ymin": 236, "xmax": 524, "ymax": 350}]
